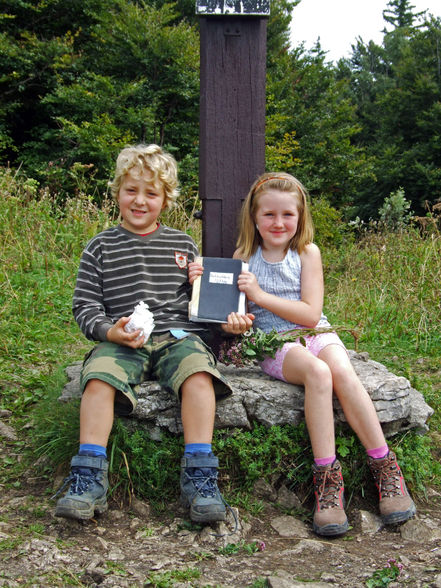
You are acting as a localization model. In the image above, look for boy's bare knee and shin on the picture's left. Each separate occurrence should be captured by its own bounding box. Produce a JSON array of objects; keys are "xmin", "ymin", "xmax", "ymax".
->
[{"xmin": 80, "ymin": 380, "xmax": 115, "ymax": 447}]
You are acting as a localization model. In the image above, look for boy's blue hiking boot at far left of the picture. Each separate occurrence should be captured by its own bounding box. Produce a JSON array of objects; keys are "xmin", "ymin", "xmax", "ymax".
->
[{"xmin": 54, "ymin": 455, "xmax": 109, "ymax": 520}]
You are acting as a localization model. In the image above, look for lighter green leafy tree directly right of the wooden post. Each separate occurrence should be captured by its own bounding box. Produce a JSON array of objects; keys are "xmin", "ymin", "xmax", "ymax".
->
[{"xmin": 266, "ymin": 13, "xmax": 370, "ymax": 211}]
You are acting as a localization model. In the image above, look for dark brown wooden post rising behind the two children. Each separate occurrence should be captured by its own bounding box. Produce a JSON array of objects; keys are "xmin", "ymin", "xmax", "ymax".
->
[{"xmin": 196, "ymin": 0, "xmax": 269, "ymax": 257}]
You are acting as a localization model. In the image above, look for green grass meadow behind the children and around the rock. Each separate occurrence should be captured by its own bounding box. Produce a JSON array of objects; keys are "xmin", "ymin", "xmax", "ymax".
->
[{"xmin": 0, "ymin": 169, "xmax": 441, "ymax": 512}]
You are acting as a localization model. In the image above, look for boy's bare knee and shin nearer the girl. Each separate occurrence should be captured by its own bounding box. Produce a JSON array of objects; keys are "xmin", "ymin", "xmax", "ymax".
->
[{"xmin": 181, "ymin": 372, "xmax": 216, "ymax": 443}]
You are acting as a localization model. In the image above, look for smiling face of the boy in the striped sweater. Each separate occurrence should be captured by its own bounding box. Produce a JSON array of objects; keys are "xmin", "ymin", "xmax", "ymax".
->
[{"xmin": 118, "ymin": 168, "xmax": 165, "ymax": 235}]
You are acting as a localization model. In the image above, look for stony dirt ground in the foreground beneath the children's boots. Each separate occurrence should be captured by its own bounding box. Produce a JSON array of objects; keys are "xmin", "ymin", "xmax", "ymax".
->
[{"xmin": 0, "ymin": 468, "xmax": 441, "ymax": 588}]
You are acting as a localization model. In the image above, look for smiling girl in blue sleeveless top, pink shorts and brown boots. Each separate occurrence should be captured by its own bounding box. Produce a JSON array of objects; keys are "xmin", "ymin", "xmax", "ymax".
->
[{"xmin": 233, "ymin": 173, "xmax": 416, "ymax": 536}]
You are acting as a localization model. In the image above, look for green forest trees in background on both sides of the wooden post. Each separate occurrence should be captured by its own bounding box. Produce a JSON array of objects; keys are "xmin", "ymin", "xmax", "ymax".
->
[{"xmin": 0, "ymin": 0, "xmax": 441, "ymax": 221}]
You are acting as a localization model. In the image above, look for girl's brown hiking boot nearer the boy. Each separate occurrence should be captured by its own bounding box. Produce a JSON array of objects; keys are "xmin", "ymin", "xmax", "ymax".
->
[{"xmin": 312, "ymin": 460, "xmax": 349, "ymax": 537}]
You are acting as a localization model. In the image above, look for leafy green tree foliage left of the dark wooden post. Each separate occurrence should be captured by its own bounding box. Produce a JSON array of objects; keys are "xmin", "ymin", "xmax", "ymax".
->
[{"xmin": 0, "ymin": 0, "xmax": 199, "ymax": 199}]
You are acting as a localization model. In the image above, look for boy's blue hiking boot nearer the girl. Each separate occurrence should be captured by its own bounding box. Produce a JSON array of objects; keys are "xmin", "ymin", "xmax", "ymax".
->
[{"xmin": 181, "ymin": 453, "xmax": 226, "ymax": 523}]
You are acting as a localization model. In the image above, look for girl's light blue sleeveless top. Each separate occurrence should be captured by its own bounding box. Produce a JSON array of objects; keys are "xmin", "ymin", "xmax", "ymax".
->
[{"xmin": 248, "ymin": 246, "xmax": 330, "ymax": 333}]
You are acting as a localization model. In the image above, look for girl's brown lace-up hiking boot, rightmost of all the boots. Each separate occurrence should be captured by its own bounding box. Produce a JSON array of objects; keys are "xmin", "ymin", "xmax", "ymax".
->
[{"xmin": 368, "ymin": 451, "xmax": 416, "ymax": 525}]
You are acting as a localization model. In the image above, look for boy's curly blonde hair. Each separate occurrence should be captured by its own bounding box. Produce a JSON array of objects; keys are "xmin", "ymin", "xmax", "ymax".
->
[{"xmin": 109, "ymin": 144, "xmax": 179, "ymax": 208}]
